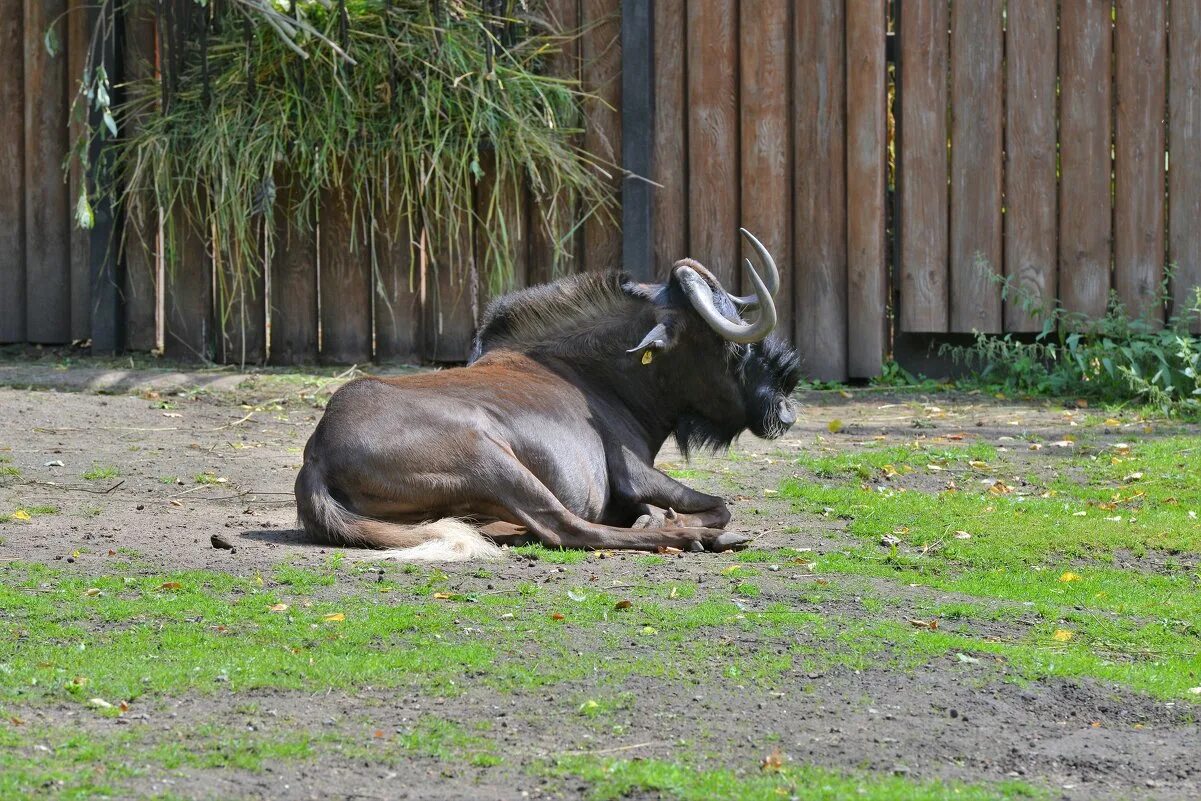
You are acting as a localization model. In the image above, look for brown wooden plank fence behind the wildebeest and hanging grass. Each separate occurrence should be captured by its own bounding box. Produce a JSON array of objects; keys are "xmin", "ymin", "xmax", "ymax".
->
[{"xmin": 0, "ymin": 0, "xmax": 1201, "ymax": 379}]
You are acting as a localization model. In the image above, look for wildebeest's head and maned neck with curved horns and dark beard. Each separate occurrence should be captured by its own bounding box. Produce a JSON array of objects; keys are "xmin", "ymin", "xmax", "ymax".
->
[{"xmin": 472, "ymin": 231, "xmax": 800, "ymax": 453}]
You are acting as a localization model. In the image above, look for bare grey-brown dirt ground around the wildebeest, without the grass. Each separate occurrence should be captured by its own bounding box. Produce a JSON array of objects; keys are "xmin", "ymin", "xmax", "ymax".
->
[{"xmin": 0, "ymin": 369, "xmax": 1201, "ymax": 799}]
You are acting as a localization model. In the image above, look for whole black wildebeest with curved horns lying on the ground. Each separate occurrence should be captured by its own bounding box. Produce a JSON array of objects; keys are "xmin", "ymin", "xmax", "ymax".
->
[{"xmin": 295, "ymin": 231, "xmax": 800, "ymax": 560}]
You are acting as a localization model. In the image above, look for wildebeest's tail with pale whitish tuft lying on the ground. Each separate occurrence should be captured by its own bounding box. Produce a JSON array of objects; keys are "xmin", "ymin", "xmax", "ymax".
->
[{"xmin": 295, "ymin": 464, "xmax": 501, "ymax": 562}]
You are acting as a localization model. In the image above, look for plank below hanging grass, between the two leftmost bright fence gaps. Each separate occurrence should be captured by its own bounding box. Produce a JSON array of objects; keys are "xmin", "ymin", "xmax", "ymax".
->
[{"xmin": 163, "ymin": 207, "xmax": 213, "ymax": 361}]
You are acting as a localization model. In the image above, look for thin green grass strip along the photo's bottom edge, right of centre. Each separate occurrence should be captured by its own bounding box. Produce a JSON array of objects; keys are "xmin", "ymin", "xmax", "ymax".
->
[{"xmin": 545, "ymin": 757, "xmax": 1046, "ymax": 801}]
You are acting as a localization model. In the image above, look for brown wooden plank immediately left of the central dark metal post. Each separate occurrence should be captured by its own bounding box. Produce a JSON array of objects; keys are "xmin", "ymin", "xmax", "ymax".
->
[{"xmin": 580, "ymin": 0, "xmax": 621, "ymax": 270}]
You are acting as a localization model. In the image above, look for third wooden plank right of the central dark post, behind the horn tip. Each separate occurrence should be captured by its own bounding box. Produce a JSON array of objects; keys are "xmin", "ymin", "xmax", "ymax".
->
[{"xmin": 735, "ymin": 0, "xmax": 794, "ymax": 340}]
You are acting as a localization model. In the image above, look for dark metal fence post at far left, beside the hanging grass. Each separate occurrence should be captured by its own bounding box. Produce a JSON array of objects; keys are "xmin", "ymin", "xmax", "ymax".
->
[{"xmin": 88, "ymin": 4, "xmax": 125, "ymax": 353}]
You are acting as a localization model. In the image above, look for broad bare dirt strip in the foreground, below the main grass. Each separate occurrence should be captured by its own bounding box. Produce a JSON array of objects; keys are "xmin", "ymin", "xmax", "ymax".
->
[{"xmin": 21, "ymin": 672, "xmax": 1201, "ymax": 801}]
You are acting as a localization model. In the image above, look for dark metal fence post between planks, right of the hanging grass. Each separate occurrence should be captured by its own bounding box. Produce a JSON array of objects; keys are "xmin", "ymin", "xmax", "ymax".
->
[{"xmin": 621, "ymin": 0, "xmax": 656, "ymax": 281}]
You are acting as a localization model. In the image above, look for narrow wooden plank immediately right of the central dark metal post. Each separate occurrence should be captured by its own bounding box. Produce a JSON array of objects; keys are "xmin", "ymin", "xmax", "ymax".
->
[{"xmin": 651, "ymin": 0, "xmax": 689, "ymax": 281}]
